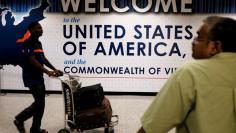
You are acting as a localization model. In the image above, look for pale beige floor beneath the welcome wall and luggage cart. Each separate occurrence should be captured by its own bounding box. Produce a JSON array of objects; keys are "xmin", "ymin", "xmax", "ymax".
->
[{"xmin": 0, "ymin": 94, "xmax": 175, "ymax": 133}]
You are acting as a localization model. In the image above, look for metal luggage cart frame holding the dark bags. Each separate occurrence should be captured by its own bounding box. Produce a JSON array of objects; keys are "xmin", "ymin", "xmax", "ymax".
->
[{"xmin": 58, "ymin": 74, "xmax": 118, "ymax": 133}]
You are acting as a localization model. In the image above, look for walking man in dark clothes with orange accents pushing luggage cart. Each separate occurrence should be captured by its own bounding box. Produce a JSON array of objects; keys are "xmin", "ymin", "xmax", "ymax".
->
[{"xmin": 14, "ymin": 22, "xmax": 62, "ymax": 133}]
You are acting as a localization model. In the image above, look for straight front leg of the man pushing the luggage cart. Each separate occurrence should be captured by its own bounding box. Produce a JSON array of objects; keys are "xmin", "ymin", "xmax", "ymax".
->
[{"xmin": 30, "ymin": 84, "xmax": 45, "ymax": 133}]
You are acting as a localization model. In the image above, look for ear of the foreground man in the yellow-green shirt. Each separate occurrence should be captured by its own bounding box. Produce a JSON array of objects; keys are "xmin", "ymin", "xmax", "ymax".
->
[{"xmin": 208, "ymin": 41, "xmax": 222, "ymax": 56}]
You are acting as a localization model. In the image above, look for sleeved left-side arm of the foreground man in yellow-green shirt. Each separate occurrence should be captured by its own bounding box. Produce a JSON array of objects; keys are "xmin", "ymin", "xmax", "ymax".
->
[{"xmin": 140, "ymin": 68, "xmax": 195, "ymax": 133}]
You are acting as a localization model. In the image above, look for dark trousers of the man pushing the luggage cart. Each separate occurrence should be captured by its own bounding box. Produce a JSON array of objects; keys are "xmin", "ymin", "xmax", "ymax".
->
[{"xmin": 15, "ymin": 84, "xmax": 45, "ymax": 132}]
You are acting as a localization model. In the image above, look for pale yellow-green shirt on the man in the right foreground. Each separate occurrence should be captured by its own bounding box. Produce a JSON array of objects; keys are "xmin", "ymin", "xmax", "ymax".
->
[{"xmin": 141, "ymin": 52, "xmax": 236, "ymax": 133}]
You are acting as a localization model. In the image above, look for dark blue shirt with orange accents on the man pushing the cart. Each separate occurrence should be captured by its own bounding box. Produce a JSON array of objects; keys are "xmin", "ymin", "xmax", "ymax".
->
[{"xmin": 21, "ymin": 38, "xmax": 45, "ymax": 87}]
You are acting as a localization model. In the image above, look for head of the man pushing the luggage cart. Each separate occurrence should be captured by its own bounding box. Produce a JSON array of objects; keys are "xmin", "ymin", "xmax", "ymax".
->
[{"xmin": 28, "ymin": 22, "xmax": 43, "ymax": 37}]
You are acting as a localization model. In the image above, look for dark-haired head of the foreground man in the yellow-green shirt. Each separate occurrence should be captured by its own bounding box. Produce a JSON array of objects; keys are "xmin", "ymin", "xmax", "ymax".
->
[{"xmin": 192, "ymin": 16, "xmax": 236, "ymax": 59}]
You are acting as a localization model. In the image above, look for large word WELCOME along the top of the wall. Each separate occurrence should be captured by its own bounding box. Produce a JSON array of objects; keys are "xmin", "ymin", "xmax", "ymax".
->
[{"xmin": 61, "ymin": 0, "xmax": 192, "ymax": 13}]
